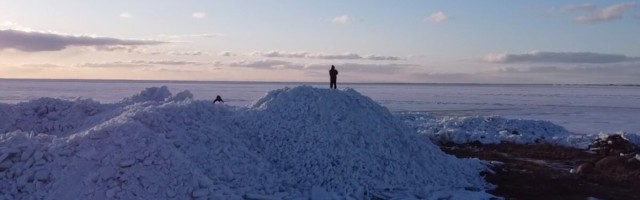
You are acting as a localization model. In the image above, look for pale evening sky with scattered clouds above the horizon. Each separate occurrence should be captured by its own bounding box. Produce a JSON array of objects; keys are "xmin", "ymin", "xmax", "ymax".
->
[{"xmin": 0, "ymin": 0, "xmax": 640, "ymax": 84}]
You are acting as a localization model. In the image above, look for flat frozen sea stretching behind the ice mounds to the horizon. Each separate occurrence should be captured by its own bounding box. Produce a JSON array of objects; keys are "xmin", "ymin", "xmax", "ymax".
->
[{"xmin": 0, "ymin": 79, "xmax": 640, "ymax": 134}]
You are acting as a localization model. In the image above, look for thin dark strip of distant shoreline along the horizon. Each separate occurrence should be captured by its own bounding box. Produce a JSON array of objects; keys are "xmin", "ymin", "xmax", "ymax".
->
[{"xmin": 0, "ymin": 78, "xmax": 640, "ymax": 87}]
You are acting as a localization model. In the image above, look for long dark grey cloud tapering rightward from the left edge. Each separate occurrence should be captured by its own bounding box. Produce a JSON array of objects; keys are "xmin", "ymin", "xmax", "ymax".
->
[{"xmin": 0, "ymin": 29, "xmax": 166, "ymax": 52}]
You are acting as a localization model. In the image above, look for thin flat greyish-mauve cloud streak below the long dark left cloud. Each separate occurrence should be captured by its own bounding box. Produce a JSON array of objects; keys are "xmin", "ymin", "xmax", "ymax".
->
[{"xmin": 76, "ymin": 60, "xmax": 215, "ymax": 68}]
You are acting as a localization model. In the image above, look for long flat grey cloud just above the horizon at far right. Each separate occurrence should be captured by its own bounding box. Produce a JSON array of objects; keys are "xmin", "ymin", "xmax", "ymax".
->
[{"xmin": 482, "ymin": 52, "xmax": 640, "ymax": 64}]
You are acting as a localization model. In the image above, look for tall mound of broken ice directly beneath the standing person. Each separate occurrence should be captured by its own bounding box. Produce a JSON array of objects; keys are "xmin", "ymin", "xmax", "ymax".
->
[{"xmin": 244, "ymin": 86, "xmax": 490, "ymax": 199}]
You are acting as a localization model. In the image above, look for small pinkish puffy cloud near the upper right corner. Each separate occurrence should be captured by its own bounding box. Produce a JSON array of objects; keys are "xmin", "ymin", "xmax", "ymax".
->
[{"xmin": 575, "ymin": 2, "xmax": 636, "ymax": 24}]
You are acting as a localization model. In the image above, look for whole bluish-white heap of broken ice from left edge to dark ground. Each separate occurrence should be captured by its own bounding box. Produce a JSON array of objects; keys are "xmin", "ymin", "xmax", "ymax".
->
[{"xmin": 0, "ymin": 86, "xmax": 491, "ymax": 199}]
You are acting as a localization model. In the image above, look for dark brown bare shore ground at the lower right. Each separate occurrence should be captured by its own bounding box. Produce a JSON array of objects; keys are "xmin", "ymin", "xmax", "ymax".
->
[{"xmin": 441, "ymin": 143, "xmax": 640, "ymax": 200}]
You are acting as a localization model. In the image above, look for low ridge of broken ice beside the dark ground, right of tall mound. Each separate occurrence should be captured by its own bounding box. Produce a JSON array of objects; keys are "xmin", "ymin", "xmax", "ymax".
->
[{"xmin": 398, "ymin": 113, "xmax": 595, "ymax": 148}]
